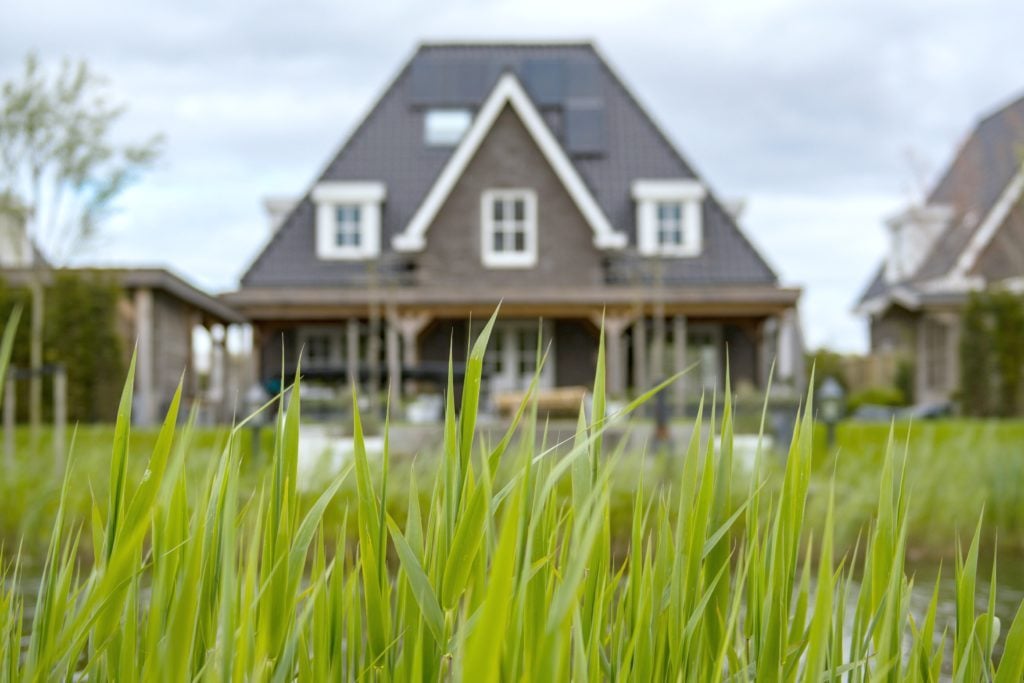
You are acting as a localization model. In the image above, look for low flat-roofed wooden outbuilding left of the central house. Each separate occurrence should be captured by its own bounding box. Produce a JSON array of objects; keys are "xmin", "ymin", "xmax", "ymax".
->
[{"xmin": 0, "ymin": 267, "xmax": 245, "ymax": 425}]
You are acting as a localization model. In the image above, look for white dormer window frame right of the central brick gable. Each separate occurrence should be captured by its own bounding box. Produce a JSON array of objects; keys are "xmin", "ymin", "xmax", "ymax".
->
[{"xmin": 633, "ymin": 180, "xmax": 708, "ymax": 258}]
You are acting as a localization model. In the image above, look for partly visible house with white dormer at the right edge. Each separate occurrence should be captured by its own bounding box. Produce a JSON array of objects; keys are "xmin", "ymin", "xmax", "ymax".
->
[{"xmin": 857, "ymin": 97, "xmax": 1024, "ymax": 403}]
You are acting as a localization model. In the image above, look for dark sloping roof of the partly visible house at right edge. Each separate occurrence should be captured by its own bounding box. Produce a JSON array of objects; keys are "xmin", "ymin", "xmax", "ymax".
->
[{"xmin": 859, "ymin": 90, "xmax": 1024, "ymax": 305}]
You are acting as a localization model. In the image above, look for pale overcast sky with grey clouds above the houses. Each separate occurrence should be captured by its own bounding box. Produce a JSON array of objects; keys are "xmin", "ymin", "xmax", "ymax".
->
[{"xmin": 0, "ymin": 0, "xmax": 1024, "ymax": 350}]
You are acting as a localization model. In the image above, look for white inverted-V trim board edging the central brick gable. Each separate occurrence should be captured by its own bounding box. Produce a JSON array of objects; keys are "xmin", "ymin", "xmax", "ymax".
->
[{"xmin": 391, "ymin": 74, "xmax": 628, "ymax": 252}]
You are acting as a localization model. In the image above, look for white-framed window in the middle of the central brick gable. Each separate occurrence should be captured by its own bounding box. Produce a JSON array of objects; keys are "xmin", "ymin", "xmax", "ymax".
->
[{"xmin": 480, "ymin": 189, "xmax": 537, "ymax": 268}]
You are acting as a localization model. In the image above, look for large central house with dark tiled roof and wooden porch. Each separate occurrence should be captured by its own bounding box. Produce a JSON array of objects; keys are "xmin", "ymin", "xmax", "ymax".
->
[{"xmin": 225, "ymin": 43, "xmax": 803, "ymax": 409}]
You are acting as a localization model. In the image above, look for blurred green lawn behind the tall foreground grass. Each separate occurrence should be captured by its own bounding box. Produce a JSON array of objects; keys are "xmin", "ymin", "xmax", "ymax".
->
[{"xmin": 6, "ymin": 413, "xmax": 1024, "ymax": 561}]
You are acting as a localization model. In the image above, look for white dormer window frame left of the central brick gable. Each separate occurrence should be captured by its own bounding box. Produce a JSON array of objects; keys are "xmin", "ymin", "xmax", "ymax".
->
[{"xmin": 312, "ymin": 181, "xmax": 387, "ymax": 261}]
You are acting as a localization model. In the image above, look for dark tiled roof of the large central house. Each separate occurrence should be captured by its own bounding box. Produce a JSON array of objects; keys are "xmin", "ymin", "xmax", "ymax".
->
[{"xmin": 242, "ymin": 43, "xmax": 777, "ymax": 287}]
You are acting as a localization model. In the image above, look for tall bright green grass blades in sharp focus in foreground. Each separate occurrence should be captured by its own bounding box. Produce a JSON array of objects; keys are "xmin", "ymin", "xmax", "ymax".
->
[{"xmin": 0, "ymin": 311, "xmax": 1024, "ymax": 682}]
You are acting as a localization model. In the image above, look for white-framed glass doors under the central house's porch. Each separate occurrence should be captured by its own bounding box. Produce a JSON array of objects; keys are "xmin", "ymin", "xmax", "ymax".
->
[{"xmin": 483, "ymin": 321, "xmax": 555, "ymax": 394}]
